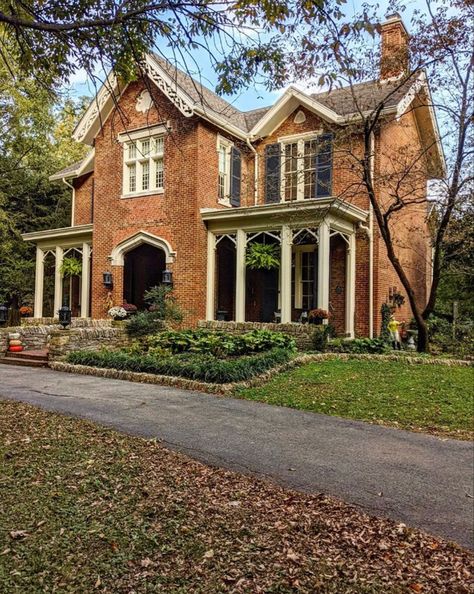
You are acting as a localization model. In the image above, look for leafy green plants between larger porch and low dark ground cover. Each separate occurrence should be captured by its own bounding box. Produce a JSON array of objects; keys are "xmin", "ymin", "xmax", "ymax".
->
[{"xmin": 146, "ymin": 330, "xmax": 295, "ymax": 357}]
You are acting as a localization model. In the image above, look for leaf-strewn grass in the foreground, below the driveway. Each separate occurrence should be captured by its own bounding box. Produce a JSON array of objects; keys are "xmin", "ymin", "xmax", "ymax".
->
[{"xmin": 0, "ymin": 402, "xmax": 474, "ymax": 594}]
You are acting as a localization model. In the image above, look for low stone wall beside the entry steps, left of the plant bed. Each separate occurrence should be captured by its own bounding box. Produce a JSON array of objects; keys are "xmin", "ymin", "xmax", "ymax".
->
[{"xmin": 49, "ymin": 326, "xmax": 130, "ymax": 361}]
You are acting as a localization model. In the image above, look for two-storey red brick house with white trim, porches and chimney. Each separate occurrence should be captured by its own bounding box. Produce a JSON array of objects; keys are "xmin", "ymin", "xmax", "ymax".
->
[{"xmin": 24, "ymin": 15, "xmax": 444, "ymax": 337}]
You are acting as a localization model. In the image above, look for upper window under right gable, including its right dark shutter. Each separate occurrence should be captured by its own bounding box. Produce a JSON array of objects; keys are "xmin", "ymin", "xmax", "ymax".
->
[{"xmin": 280, "ymin": 134, "xmax": 332, "ymax": 202}]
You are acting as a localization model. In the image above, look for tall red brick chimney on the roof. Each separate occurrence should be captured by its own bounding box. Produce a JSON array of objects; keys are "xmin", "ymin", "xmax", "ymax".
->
[{"xmin": 380, "ymin": 12, "xmax": 410, "ymax": 80}]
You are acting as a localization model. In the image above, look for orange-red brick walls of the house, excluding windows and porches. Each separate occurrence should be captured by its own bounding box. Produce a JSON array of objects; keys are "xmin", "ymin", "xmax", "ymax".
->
[{"xmin": 83, "ymin": 74, "xmax": 432, "ymax": 335}]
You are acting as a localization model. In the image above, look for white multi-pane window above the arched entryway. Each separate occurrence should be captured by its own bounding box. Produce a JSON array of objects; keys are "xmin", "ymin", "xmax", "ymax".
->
[{"xmin": 123, "ymin": 135, "xmax": 164, "ymax": 196}]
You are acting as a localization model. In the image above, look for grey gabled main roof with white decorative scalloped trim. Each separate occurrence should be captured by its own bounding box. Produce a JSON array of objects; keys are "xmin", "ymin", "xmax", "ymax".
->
[{"xmin": 64, "ymin": 53, "xmax": 444, "ymax": 179}]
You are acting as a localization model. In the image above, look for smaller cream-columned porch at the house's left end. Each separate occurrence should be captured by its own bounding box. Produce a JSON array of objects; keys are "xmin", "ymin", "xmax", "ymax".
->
[{"xmin": 22, "ymin": 225, "xmax": 92, "ymax": 318}]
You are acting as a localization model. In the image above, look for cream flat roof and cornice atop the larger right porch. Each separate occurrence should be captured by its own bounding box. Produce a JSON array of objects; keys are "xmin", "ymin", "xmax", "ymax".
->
[{"xmin": 201, "ymin": 198, "xmax": 369, "ymax": 231}]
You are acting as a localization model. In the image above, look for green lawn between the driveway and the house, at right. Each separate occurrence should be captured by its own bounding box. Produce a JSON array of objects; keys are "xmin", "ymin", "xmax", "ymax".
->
[{"xmin": 235, "ymin": 360, "xmax": 474, "ymax": 439}]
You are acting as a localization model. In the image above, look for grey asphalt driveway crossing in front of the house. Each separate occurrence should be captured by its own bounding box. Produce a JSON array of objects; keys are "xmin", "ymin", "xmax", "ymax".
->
[{"xmin": 0, "ymin": 365, "xmax": 474, "ymax": 548}]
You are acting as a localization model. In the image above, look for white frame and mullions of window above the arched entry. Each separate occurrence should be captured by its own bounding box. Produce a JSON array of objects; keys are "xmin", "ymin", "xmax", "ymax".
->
[{"xmin": 118, "ymin": 126, "xmax": 166, "ymax": 198}]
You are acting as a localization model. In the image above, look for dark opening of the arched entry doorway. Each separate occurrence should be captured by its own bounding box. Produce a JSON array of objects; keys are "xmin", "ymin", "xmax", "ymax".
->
[{"xmin": 123, "ymin": 243, "xmax": 166, "ymax": 309}]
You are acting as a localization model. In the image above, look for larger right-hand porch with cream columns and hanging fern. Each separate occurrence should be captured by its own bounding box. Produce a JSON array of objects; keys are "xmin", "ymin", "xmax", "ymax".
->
[{"xmin": 201, "ymin": 199, "xmax": 367, "ymax": 337}]
